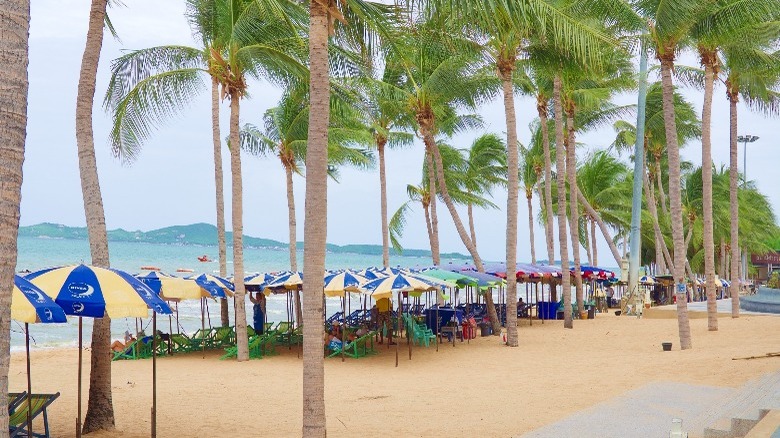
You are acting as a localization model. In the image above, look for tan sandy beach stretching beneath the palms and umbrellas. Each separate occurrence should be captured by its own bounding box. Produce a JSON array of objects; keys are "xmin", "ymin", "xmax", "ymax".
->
[{"xmin": 9, "ymin": 314, "xmax": 780, "ymax": 437}]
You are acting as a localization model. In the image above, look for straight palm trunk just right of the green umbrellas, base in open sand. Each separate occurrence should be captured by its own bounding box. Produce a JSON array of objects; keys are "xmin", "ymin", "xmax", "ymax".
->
[{"xmin": 500, "ymin": 63, "xmax": 516, "ymax": 347}]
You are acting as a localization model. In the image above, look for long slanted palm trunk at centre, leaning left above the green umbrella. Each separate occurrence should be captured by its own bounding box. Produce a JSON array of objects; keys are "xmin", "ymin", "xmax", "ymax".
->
[{"xmin": 421, "ymin": 127, "xmax": 502, "ymax": 330}]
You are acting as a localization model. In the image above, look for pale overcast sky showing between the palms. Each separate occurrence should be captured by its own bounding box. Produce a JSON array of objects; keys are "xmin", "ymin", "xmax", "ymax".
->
[{"xmin": 21, "ymin": 0, "xmax": 780, "ymax": 266}]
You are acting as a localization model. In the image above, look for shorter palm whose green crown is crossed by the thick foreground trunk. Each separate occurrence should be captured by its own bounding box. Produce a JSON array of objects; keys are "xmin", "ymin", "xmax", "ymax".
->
[{"xmin": 241, "ymin": 87, "xmax": 373, "ymax": 323}]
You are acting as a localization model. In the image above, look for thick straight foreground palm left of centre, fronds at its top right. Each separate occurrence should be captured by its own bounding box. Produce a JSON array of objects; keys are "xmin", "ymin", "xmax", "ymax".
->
[{"xmin": 303, "ymin": 0, "xmax": 392, "ymax": 437}]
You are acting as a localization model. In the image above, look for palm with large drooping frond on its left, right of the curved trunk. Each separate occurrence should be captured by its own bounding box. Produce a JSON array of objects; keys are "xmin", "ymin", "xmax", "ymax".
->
[{"xmin": 106, "ymin": 0, "xmax": 308, "ymax": 360}]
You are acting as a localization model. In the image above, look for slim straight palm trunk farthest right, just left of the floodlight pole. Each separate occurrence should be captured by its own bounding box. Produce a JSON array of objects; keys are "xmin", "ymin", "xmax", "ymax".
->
[{"xmin": 729, "ymin": 87, "xmax": 740, "ymax": 318}]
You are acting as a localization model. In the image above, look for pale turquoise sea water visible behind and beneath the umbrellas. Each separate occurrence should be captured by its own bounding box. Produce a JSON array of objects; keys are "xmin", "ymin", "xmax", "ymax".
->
[{"xmin": 11, "ymin": 237, "xmax": 458, "ymax": 350}]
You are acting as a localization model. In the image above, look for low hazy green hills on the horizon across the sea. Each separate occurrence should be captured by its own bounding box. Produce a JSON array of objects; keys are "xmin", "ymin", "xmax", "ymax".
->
[{"xmin": 19, "ymin": 223, "xmax": 470, "ymax": 259}]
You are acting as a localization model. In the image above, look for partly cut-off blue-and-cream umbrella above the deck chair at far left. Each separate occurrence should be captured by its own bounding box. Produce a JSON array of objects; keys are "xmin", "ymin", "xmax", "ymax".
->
[{"xmin": 11, "ymin": 275, "xmax": 68, "ymax": 433}]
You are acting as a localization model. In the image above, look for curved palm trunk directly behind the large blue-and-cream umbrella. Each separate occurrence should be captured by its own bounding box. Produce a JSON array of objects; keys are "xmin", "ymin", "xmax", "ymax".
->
[{"xmin": 76, "ymin": 0, "xmax": 114, "ymax": 433}]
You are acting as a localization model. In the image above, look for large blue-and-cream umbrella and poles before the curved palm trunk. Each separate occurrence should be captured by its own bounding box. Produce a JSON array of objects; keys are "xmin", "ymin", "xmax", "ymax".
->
[{"xmin": 26, "ymin": 264, "xmax": 171, "ymax": 437}]
